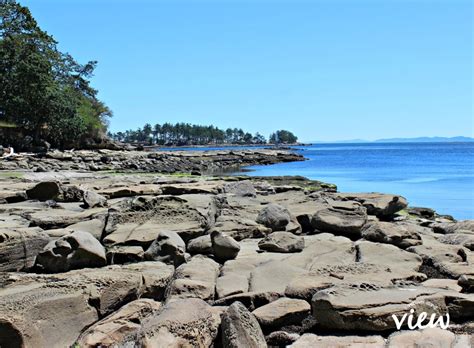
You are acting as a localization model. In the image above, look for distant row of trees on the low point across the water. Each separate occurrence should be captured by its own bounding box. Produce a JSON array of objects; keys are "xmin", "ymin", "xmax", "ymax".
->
[{"xmin": 109, "ymin": 123, "xmax": 298, "ymax": 146}]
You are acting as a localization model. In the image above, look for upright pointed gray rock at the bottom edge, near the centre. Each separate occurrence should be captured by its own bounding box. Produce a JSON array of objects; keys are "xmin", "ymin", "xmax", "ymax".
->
[{"xmin": 221, "ymin": 302, "xmax": 267, "ymax": 348}]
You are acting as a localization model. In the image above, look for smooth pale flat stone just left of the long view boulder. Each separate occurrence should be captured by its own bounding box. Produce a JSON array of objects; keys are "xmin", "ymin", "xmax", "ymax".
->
[{"xmin": 252, "ymin": 297, "xmax": 311, "ymax": 328}]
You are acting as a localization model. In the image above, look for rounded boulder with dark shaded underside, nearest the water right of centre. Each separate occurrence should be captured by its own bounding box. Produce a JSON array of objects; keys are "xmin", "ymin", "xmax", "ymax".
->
[{"xmin": 311, "ymin": 201, "xmax": 367, "ymax": 239}]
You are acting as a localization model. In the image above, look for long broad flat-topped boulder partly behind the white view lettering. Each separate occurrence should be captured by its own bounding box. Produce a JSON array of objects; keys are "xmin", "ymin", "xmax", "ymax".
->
[{"xmin": 312, "ymin": 281, "xmax": 474, "ymax": 331}]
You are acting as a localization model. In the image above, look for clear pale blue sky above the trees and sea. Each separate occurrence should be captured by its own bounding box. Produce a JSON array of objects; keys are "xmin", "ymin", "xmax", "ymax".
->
[{"xmin": 20, "ymin": 0, "xmax": 474, "ymax": 141}]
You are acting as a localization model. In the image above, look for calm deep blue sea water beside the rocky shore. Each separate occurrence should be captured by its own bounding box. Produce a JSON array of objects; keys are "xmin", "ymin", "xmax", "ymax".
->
[{"xmin": 246, "ymin": 143, "xmax": 474, "ymax": 220}]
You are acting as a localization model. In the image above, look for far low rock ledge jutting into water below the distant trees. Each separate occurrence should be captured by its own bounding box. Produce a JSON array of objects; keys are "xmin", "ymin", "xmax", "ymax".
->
[{"xmin": 0, "ymin": 149, "xmax": 304, "ymax": 174}]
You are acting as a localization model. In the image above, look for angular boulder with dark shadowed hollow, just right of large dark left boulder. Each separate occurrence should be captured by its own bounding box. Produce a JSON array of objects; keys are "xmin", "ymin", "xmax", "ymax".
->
[{"xmin": 145, "ymin": 231, "xmax": 186, "ymax": 267}]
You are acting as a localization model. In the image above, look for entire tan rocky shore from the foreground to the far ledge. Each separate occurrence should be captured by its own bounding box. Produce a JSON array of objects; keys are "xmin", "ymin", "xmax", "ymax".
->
[{"xmin": 0, "ymin": 150, "xmax": 474, "ymax": 348}]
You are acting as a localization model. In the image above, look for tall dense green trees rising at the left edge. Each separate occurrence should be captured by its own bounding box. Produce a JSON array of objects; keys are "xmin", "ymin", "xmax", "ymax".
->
[{"xmin": 0, "ymin": 0, "xmax": 112, "ymax": 149}]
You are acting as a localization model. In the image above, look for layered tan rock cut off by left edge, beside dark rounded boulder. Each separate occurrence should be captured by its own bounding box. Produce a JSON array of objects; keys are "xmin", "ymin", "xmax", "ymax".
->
[{"xmin": 0, "ymin": 227, "xmax": 50, "ymax": 272}]
